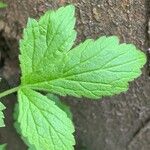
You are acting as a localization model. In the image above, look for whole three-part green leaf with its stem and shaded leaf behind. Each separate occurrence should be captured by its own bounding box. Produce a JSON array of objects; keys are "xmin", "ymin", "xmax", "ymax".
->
[{"xmin": 0, "ymin": 5, "xmax": 146, "ymax": 150}]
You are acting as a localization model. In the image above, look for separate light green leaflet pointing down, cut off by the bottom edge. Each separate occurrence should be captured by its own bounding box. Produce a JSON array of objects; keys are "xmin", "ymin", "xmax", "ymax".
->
[{"xmin": 18, "ymin": 88, "xmax": 75, "ymax": 150}]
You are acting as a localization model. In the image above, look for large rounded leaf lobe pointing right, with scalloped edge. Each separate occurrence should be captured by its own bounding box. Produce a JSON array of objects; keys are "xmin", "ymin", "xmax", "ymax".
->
[{"xmin": 20, "ymin": 33, "xmax": 146, "ymax": 98}]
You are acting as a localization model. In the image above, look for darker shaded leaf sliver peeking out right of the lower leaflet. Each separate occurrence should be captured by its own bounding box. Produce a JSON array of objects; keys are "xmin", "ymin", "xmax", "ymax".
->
[{"xmin": 46, "ymin": 93, "xmax": 73, "ymax": 120}]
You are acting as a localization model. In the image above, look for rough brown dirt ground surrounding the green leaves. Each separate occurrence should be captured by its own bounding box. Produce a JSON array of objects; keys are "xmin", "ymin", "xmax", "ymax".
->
[{"xmin": 0, "ymin": 0, "xmax": 150, "ymax": 150}]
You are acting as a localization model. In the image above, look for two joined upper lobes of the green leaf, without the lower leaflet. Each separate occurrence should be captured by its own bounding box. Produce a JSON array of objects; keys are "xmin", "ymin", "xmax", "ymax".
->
[{"xmin": 20, "ymin": 6, "xmax": 146, "ymax": 98}]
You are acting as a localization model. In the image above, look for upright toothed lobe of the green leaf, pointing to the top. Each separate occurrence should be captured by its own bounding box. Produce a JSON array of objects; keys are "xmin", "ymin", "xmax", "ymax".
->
[{"xmin": 20, "ymin": 5, "xmax": 76, "ymax": 77}]
